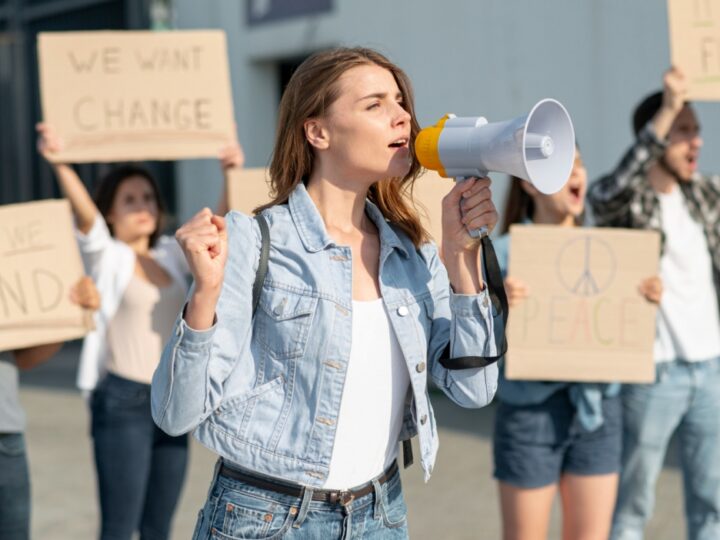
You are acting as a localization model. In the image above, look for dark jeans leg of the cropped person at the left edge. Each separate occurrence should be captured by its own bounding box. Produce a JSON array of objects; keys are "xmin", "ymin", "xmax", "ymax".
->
[{"xmin": 0, "ymin": 433, "xmax": 30, "ymax": 540}]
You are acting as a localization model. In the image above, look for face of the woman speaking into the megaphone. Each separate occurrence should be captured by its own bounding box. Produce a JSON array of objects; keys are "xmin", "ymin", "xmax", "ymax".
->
[{"xmin": 306, "ymin": 64, "xmax": 411, "ymax": 183}]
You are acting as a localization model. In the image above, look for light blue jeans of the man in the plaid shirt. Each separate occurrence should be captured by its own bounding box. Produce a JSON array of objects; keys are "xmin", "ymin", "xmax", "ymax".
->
[{"xmin": 611, "ymin": 359, "xmax": 720, "ymax": 540}]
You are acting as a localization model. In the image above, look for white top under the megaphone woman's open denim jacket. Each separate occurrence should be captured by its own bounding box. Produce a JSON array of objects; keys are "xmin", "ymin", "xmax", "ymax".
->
[{"xmin": 324, "ymin": 299, "xmax": 410, "ymax": 489}]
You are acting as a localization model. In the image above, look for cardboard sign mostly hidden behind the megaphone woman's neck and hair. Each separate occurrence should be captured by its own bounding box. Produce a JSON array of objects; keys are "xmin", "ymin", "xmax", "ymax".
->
[{"xmin": 228, "ymin": 168, "xmax": 455, "ymax": 244}]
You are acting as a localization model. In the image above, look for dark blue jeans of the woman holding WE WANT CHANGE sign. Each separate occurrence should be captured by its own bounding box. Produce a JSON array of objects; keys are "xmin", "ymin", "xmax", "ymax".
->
[{"xmin": 91, "ymin": 374, "xmax": 188, "ymax": 540}]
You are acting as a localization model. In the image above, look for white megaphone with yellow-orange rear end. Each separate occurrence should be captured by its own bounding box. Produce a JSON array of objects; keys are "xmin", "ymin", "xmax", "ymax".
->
[{"xmin": 415, "ymin": 99, "xmax": 575, "ymax": 234}]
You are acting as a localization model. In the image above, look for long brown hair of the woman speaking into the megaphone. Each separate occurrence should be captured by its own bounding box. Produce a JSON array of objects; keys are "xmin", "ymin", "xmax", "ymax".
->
[{"xmin": 255, "ymin": 47, "xmax": 428, "ymax": 247}]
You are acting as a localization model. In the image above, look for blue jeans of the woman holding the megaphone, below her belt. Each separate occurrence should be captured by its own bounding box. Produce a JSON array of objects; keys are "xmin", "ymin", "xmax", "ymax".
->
[{"xmin": 193, "ymin": 462, "xmax": 408, "ymax": 540}]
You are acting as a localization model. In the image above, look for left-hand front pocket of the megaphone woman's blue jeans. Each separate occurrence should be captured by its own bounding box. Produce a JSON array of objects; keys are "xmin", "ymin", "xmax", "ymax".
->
[{"xmin": 211, "ymin": 489, "xmax": 297, "ymax": 540}]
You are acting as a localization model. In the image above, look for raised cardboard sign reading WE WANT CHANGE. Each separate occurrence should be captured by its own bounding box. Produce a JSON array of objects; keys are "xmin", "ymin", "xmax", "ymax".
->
[{"xmin": 38, "ymin": 30, "xmax": 236, "ymax": 163}]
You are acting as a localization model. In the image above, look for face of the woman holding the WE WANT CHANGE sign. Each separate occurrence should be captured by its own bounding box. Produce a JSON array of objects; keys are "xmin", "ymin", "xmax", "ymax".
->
[{"xmin": 107, "ymin": 176, "xmax": 159, "ymax": 242}]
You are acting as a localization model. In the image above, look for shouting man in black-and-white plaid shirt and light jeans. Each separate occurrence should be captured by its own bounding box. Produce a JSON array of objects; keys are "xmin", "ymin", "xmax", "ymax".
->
[{"xmin": 588, "ymin": 69, "xmax": 720, "ymax": 540}]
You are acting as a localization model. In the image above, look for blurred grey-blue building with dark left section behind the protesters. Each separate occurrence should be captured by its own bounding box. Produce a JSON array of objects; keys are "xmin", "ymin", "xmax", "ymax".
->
[{"xmin": 0, "ymin": 0, "xmax": 720, "ymax": 227}]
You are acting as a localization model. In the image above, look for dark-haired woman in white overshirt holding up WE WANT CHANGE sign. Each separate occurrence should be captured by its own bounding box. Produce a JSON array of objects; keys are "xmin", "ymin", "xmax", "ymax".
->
[{"xmin": 33, "ymin": 110, "xmax": 244, "ymax": 537}]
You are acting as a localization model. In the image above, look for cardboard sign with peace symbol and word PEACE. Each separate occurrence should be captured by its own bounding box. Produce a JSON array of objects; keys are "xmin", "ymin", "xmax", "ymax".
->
[{"xmin": 506, "ymin": 225, "xmax": 660, "ymax": 383}]
